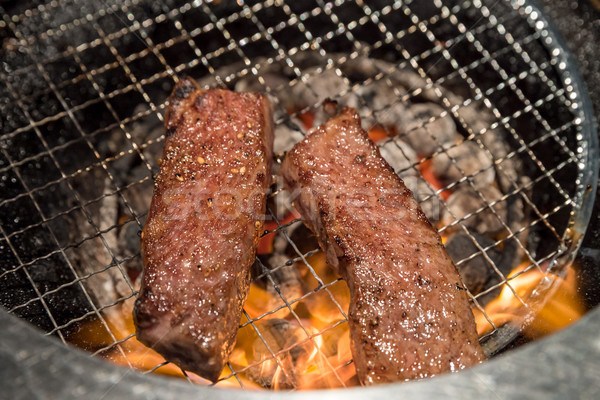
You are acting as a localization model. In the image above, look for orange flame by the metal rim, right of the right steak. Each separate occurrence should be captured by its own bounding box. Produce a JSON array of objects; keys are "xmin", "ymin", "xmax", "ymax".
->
[{"xmin": 473, "ymin": 263, "xmax": 585, "ymax": 339}]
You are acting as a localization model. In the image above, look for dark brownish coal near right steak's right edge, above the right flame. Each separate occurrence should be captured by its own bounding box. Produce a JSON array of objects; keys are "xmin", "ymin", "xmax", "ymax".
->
[{"xmin": 446, "ymin": 233, "xmax": 501, "ymax": 295}]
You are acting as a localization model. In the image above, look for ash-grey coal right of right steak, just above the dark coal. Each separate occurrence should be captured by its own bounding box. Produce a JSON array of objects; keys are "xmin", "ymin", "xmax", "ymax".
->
[{"xmin": 442, "ymin": 184, "xmax": 507, "ymax": 234}]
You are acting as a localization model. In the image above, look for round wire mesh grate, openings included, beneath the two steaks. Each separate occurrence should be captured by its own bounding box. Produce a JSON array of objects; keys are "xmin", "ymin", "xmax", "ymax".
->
[{"xmin": 0, "ymin": 0, "xmax": 587, "ymax": 389}]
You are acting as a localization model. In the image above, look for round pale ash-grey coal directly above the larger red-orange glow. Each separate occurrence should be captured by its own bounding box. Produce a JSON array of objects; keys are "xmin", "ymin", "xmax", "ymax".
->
[{"xmin": 401, "ymin": 103, "xmax": 456, "ymax": 156}]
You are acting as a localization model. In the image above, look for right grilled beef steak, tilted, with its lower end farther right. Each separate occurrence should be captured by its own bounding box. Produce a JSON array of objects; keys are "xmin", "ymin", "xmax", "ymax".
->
[{"xmin": 281, "ymin": 108, "xmax": 485, "ymax": 385}]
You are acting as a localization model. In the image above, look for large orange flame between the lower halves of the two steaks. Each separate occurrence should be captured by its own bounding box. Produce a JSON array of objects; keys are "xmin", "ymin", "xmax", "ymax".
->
[{"xmin": 230, "ymin": 252, "xmax": 358, "ymax": 390}]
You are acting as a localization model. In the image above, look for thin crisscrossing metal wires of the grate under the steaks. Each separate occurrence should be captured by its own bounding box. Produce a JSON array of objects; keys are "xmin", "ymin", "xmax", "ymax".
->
[{"xmin": 0, "ymin": 0, "xmax": 585, "ymax": 388}]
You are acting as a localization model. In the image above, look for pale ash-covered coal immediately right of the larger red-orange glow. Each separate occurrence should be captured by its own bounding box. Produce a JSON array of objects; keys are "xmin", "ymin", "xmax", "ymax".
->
[{"xmin": 433, "ymin": 141, "xmax": 496, "ymax": 188}]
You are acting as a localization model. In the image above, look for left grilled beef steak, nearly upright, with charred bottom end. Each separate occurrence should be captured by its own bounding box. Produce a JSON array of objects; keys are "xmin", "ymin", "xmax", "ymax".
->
[{"xmin": 134, "ymin": 79, "xmax": 273, "ymax": 381}]
